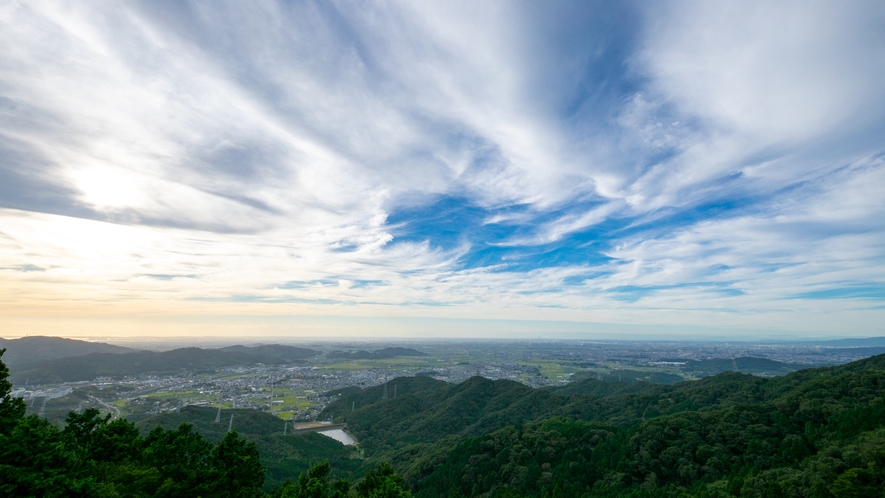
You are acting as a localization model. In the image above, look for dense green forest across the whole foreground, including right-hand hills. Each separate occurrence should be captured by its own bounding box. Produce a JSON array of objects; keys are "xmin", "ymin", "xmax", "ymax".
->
[{"xmin": 0, "ymin": 348, "xmax": 885, "ymax": 498}]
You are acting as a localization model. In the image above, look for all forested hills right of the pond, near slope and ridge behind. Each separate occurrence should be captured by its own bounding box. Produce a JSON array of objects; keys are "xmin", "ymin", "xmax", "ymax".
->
[{"xmin": 327, "ymin": 356, "xmax": 885, "ymax": 497}]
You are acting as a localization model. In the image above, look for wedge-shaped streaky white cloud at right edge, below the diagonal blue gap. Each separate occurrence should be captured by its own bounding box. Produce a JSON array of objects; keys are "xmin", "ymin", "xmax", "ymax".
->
[{"xmin": 610, "ymin": 154, "xmax": 885, "ymax": 306}]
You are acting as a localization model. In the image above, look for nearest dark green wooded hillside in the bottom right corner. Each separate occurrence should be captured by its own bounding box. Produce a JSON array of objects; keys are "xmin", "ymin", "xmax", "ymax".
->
[{"xmin": 406, "ymin": 357, "xmax": 885, "ymax": 497}]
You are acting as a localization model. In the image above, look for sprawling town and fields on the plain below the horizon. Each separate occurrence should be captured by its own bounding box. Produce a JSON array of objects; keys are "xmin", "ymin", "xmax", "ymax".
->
[{"xmin": 13, "ymin": 341, "xmax": 883, "ymax": 432}]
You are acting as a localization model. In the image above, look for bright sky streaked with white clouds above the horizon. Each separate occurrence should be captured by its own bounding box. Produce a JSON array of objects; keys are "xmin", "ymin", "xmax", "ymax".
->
[{"xmin": 0, "ymin": 0, "xmax": 885, "ymax": 339}]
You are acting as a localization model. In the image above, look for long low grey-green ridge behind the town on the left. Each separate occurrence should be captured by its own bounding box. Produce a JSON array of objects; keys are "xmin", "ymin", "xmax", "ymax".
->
[{"xmin": 10, "ymin": 345, "xmax": 319, "ymax": 384}]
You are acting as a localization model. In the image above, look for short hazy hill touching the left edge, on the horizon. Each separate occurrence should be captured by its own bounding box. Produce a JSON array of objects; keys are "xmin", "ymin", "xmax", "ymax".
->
[{"xmin": 0, "ymin": 336, "xmax": 135, "ymax": 369}]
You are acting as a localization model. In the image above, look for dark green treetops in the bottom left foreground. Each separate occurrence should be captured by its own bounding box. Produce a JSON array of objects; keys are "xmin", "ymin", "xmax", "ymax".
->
[{"xmin": 0, "ymin": 349, "xmax": 410, "ymax": 498}]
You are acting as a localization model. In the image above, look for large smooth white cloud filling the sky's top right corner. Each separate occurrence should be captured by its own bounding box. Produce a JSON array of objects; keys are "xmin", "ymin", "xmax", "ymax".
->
[{"xmin": 631, "ymin": 1, "xmax": 885, "ymax": 209}]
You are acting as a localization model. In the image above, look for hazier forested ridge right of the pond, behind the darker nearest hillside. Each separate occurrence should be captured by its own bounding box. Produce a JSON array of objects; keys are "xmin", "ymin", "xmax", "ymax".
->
[{"xmin": 321, "ymin": 366, "xmax": 796, "ymax": 452}]
